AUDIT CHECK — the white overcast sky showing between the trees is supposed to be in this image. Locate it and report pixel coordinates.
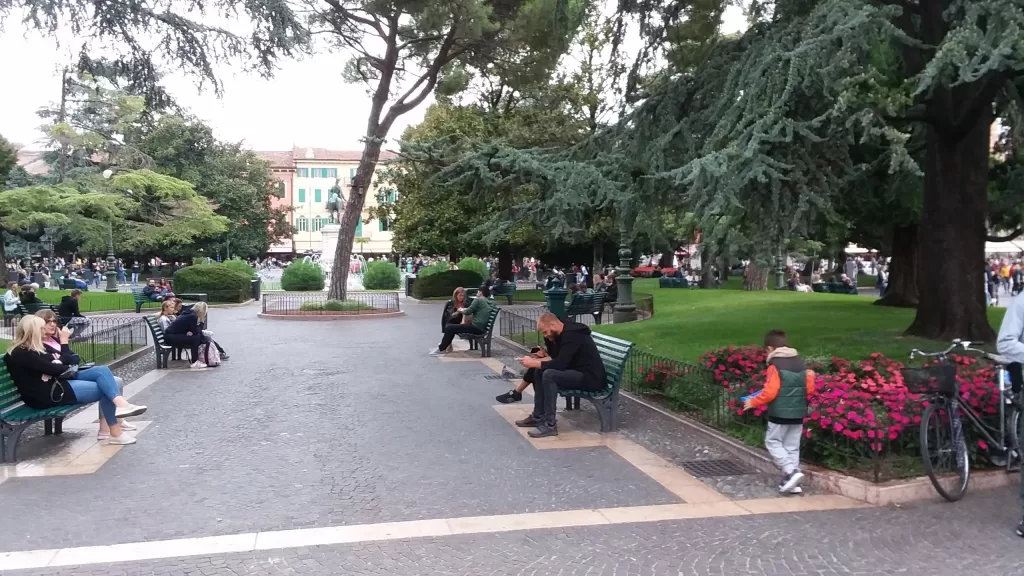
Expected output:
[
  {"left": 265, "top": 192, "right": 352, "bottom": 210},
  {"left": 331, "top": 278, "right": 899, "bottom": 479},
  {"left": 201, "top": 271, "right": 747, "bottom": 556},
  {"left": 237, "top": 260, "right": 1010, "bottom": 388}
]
[{"left": 0, "top": 7, "right": 744, "bottom": 151}]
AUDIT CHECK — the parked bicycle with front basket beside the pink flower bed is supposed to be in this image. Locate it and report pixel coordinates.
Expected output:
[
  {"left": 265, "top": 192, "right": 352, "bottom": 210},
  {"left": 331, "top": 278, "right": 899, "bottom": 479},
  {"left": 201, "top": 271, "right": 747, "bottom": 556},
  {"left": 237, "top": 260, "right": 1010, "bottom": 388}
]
[{"left": 901, "top": 338, "right": 1024, "bottom": 502}]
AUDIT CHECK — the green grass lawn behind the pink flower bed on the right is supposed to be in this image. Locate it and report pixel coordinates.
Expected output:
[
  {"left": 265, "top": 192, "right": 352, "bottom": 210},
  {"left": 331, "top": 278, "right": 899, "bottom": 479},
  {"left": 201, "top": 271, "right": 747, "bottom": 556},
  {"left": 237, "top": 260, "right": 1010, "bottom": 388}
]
[{"left": 598, "top": 279, "right": 1005, "bottom": 361}]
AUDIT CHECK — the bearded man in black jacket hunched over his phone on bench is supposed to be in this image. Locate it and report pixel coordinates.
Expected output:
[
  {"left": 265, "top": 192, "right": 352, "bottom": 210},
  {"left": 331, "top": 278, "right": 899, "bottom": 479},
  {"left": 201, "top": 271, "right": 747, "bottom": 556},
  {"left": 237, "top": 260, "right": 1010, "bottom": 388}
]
[{"left": 515, "top": 313, "right": 605, "bottom": 438}]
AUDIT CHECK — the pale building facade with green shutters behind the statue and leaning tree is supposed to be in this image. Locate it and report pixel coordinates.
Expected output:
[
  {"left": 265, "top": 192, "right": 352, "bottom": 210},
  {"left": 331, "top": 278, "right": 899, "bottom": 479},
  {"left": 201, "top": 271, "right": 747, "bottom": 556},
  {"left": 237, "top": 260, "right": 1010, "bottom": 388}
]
[{"left": 257, "top": 148, "right": 394, "bottom": 255}]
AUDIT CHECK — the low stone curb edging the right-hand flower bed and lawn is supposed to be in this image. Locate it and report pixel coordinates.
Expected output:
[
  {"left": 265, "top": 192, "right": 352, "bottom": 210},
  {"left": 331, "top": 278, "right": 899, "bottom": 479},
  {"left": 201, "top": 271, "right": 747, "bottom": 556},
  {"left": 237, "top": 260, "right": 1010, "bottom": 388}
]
[{"left": 496, "top": 335, "right": 1018, "bottom": 505}]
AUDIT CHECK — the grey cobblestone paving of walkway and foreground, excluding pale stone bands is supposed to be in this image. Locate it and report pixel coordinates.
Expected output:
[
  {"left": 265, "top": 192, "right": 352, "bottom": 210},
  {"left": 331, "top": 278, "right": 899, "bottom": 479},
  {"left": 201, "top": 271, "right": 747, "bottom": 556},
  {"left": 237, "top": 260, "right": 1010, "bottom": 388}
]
[{"left": 0, "top": 300, "right": 1024, "bottom": 576}]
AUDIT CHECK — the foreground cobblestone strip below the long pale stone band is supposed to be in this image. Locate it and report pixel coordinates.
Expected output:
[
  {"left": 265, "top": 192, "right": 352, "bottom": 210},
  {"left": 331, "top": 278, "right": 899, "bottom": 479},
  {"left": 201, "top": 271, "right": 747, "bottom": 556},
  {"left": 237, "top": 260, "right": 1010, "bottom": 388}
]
[{"left": 10, "top": 489, "right": 1024, "bottom": 576}]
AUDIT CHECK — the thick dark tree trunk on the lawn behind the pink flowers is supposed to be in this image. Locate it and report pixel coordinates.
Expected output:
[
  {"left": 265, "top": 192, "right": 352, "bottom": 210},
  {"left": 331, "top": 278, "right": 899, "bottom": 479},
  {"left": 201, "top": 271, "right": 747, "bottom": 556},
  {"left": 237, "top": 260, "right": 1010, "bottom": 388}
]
[{"left": 906, "top": 111, "right": 995, "bottom": 341}]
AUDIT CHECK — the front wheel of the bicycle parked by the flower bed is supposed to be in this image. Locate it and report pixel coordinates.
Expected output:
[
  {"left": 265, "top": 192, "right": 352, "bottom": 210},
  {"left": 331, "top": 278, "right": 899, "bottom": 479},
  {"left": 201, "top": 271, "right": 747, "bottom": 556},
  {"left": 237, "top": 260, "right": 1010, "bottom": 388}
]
[{"left": 921, "top": 401, "right": 971, "bottom": 502}]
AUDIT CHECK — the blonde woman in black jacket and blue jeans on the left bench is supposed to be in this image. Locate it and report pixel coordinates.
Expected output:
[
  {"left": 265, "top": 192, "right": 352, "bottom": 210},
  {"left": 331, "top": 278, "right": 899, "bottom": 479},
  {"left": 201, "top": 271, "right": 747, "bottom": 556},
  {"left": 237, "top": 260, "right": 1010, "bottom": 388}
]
[{"left": 3, "top": 315, "right": 145, "bottom": 445}]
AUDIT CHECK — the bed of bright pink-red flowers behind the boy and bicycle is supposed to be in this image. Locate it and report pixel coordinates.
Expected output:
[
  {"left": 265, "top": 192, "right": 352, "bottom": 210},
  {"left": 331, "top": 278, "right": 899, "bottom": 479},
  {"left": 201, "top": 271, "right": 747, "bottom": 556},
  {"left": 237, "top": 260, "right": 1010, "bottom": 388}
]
[{"left": 630, "top": 346, "right": 998, "bottom": 482}]
